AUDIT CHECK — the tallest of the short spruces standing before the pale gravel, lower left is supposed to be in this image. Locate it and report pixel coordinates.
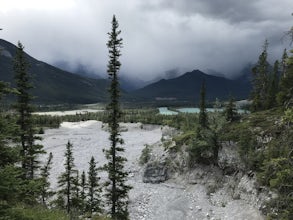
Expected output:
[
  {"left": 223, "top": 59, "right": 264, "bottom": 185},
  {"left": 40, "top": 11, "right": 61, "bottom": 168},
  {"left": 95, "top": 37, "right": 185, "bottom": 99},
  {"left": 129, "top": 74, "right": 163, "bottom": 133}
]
[{"left": 57, "top": 141, "right": 76, "bottom": 213}]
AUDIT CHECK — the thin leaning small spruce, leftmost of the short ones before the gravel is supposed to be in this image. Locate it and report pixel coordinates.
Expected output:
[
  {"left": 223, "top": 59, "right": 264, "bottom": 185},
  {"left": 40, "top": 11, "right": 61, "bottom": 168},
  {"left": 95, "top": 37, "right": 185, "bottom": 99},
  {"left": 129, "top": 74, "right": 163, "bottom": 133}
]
[{"left": 40, "top": 152, "right": 54, "bottom": 206}]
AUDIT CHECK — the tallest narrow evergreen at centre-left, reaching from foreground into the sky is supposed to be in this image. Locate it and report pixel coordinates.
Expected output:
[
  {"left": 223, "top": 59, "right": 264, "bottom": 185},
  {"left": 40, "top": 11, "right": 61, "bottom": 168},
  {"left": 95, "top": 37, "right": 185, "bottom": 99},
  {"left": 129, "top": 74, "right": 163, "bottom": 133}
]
[{"left": 104, "top": 15, "right": 131, "bottom": 220}]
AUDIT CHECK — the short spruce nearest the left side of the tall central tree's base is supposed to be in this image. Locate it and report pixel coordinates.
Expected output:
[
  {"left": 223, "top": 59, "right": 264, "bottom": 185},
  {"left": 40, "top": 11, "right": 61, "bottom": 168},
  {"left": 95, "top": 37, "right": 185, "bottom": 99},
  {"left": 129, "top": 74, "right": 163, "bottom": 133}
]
[{"left": 86, "top": 157, "right": 102, "bottom": 216}]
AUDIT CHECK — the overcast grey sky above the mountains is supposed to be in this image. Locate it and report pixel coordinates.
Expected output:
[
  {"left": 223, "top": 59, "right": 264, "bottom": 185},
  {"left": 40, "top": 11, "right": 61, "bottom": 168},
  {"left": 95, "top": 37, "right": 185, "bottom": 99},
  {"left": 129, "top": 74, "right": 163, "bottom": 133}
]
[{"left": 0, "top": 0, "right": 293, "bottom": 80}]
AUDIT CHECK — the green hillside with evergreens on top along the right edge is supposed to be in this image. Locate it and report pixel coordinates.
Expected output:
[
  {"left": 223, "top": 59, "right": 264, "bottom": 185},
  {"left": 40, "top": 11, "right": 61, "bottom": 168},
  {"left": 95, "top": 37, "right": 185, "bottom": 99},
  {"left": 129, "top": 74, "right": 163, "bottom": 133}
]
[{"left": 248, "top": 32, "right": 293, "bottom": 219}]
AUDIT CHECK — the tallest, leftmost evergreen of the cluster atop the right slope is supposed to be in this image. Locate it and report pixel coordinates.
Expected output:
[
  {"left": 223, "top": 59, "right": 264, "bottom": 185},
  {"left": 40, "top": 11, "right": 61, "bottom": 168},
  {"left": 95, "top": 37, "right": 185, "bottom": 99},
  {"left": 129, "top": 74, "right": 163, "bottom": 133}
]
[{"left": 251, "top": 40, "right": 269, "bottom": 111}]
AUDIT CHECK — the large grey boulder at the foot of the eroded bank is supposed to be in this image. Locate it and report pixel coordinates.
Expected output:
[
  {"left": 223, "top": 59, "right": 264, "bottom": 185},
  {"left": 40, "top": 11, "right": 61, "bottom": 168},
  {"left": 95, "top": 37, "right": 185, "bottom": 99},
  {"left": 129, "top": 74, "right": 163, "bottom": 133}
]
[{"left": 142, "top": 162, "right": 168, "bottom": 183}]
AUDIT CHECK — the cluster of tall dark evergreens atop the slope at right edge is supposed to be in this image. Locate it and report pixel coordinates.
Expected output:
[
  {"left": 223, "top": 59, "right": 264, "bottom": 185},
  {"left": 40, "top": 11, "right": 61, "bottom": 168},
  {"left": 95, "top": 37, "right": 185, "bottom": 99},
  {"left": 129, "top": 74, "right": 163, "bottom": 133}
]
[{"left": 251, "top": 37, "right": 293, "bottom": 112}]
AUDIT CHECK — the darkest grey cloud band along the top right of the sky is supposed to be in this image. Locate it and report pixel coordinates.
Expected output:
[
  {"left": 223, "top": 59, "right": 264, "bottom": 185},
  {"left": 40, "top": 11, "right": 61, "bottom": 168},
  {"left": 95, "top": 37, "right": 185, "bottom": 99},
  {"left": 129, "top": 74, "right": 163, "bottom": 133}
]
[{"left": 143, "top": 0, "right": 292, "bottom": 23}]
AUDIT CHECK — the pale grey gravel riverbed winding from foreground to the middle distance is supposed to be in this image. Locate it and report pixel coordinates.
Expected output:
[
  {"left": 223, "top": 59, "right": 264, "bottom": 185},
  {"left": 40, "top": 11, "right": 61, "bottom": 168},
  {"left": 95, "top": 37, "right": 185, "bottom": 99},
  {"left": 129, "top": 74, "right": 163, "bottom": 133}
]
[{"left": 41, "top": 121, "right": 264, "bottom": 220}]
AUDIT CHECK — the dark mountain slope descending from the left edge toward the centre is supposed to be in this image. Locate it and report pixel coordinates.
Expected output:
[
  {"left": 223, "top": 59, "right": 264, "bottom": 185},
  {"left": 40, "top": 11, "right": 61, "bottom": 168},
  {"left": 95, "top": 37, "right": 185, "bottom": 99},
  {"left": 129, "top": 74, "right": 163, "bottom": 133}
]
[{"left": 0, "top": 40, "right": 108, "bottom": 104}]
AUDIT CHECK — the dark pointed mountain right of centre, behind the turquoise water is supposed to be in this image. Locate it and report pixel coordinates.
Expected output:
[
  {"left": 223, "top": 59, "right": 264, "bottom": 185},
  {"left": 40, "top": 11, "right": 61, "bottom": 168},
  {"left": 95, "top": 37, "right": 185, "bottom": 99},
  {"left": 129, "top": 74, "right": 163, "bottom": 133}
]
[{"left": 133, "top": 69, "right": 250, "bottom": 102}]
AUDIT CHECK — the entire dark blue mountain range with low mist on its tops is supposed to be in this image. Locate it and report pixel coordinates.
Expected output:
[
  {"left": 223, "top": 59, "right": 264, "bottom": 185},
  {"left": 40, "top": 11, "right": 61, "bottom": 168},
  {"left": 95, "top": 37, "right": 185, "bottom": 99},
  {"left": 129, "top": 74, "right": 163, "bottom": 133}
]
[{"left": 0, "top": 40, "right": 251, "bottom": 103}]
